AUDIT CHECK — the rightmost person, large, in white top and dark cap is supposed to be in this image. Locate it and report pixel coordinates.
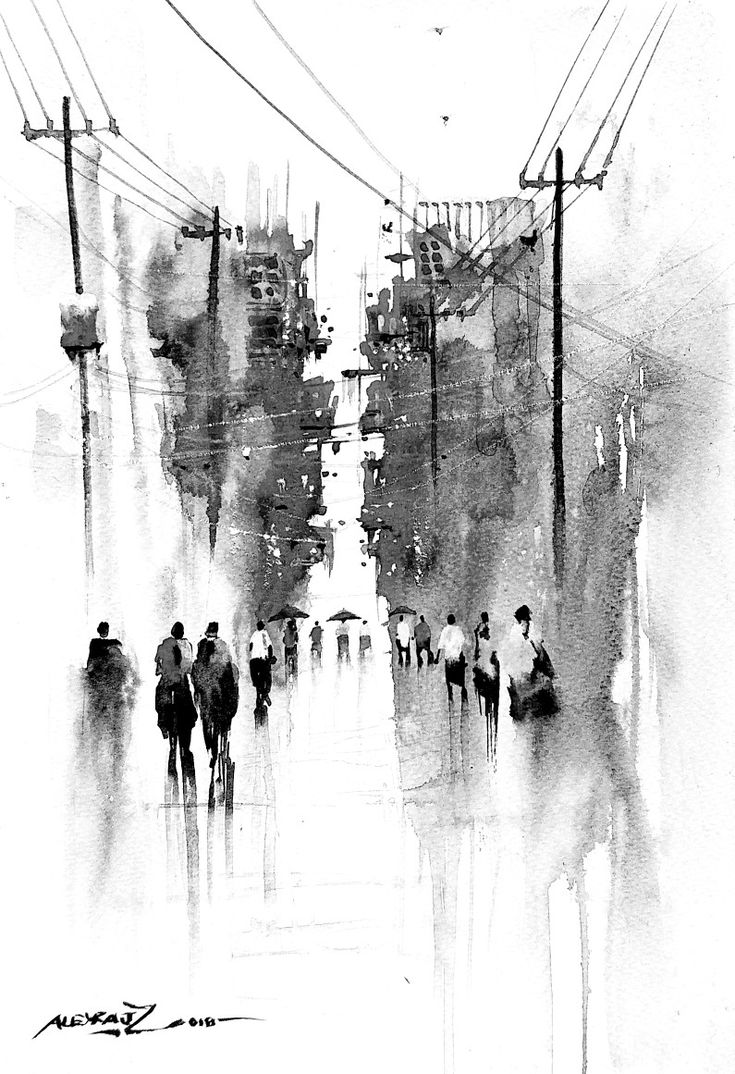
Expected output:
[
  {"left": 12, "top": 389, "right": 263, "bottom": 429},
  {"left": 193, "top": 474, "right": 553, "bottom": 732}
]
[{"left": 504, "top": 605, "right": 559, "bottom": 721}]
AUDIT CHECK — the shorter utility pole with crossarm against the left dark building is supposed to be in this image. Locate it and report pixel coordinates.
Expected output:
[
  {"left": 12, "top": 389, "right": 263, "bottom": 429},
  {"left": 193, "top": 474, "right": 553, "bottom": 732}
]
[{"left": 182, "top": 205, "right": 231, "bottom": 558}]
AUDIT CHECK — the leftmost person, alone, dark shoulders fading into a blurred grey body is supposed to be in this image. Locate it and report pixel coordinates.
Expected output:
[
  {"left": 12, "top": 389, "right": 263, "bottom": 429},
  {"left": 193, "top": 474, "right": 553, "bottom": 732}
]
[{"left": 86, "top": 621, "right": 139, "bottom": 768}]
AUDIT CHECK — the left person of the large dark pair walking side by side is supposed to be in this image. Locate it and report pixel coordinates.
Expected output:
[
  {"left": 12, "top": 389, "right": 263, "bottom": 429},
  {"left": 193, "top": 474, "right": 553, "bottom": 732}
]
[{"left": 156, "top": 623, "right": 197, "bottom": 765}]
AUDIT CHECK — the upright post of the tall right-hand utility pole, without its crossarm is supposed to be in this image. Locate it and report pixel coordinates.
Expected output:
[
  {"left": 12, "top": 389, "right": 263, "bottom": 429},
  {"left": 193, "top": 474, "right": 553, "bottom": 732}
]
[{"left": 551, "top": 147, "right": 566, "bottom": 585}]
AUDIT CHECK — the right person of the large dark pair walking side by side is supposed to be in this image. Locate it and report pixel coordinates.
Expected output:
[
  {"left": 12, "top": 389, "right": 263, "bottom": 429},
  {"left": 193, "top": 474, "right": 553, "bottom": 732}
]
[{"left": 191, "top": 622, "right": 240, "bottom": 768}]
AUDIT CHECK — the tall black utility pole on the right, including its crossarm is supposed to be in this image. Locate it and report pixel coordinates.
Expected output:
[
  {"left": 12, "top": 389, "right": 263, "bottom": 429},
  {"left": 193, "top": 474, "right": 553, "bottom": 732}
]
[{"left": 519, "top": 146, "right": 607, "bottom": 590}]
